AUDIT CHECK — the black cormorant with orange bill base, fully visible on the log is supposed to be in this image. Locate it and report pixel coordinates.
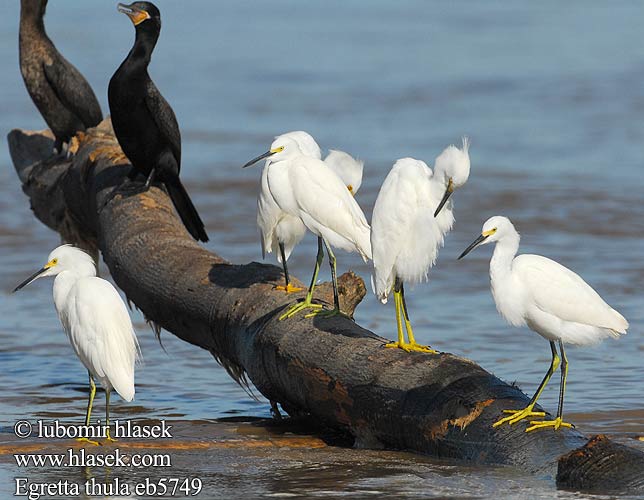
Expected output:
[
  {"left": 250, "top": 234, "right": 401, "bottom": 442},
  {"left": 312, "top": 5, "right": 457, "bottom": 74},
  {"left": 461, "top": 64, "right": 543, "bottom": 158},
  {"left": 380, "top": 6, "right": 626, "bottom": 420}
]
[{"left": 108, "top": 2, "right": 208, "bottom": 241}]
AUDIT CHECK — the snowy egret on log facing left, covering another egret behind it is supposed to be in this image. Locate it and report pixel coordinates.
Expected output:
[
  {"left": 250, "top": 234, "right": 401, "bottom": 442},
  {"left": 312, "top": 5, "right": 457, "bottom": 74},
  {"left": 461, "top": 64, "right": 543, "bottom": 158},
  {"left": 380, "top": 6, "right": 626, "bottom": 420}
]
[{"left": 244, "top": 136, "right": 371, "bottom": 319}]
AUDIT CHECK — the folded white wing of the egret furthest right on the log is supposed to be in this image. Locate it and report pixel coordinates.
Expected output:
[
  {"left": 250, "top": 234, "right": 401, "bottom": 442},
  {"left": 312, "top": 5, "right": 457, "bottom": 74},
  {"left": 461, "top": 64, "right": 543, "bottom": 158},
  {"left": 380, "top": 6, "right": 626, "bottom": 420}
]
[{"left": 512, "top": 255, "right": 628, "bottom": 332}]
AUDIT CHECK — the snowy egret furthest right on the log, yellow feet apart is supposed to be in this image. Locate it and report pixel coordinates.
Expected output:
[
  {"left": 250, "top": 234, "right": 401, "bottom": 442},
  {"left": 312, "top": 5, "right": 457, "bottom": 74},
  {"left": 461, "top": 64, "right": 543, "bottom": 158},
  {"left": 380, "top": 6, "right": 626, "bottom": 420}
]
[{"left": 459, "top": 216, "right": 628, "bottom": 432}]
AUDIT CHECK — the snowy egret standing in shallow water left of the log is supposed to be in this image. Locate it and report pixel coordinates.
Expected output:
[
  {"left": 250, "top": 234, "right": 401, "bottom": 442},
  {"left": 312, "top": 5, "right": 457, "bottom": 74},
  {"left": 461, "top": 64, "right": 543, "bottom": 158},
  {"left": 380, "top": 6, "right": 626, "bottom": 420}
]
[{"left": 14, "top": 245, "right": 139, "bottom": 444}]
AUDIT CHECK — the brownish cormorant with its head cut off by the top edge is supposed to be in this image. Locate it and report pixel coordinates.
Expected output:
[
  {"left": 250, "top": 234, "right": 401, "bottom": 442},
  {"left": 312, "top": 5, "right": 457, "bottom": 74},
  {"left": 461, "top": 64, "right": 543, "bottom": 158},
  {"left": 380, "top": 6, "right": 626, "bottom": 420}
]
[{"left": 20, "top": 0, "right": 103, "bottom": 152}]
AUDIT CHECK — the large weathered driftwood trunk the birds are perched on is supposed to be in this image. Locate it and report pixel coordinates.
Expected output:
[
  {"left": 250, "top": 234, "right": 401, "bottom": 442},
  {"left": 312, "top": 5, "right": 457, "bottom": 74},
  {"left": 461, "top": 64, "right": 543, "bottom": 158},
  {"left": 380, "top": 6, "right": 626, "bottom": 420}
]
[{"left": 8, "top": 120, "right": 644, "bottom": 490}]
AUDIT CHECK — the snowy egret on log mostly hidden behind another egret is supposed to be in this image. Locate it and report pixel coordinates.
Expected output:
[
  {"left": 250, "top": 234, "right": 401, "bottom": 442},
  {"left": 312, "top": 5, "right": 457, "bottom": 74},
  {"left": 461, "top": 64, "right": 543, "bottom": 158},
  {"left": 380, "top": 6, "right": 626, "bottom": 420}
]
[{"left": 257, "top": 130, "right": 363, "bottom": 291}]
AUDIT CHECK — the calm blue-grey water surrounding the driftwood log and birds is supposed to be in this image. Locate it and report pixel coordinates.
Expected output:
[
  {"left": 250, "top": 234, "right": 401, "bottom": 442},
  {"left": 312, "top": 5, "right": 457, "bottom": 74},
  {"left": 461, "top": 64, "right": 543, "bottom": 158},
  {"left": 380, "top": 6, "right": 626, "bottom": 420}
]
[{"left": 0, "top": 0, "right": 644, "bottom": 497}]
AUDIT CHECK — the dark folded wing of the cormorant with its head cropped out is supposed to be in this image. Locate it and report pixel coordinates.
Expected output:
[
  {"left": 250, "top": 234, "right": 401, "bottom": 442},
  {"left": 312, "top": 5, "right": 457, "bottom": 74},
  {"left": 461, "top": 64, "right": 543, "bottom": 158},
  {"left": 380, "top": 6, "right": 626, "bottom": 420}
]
[{"left": 43, "top": 56, "right": 103, "bottom": 128}]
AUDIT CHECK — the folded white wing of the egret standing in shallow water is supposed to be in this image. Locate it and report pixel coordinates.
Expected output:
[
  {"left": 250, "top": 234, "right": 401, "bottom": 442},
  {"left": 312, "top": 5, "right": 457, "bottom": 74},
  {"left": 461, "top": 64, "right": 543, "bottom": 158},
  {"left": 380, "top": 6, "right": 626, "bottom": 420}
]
[{"left": 66, "top": 277, "right": 138, "bottom": 401}]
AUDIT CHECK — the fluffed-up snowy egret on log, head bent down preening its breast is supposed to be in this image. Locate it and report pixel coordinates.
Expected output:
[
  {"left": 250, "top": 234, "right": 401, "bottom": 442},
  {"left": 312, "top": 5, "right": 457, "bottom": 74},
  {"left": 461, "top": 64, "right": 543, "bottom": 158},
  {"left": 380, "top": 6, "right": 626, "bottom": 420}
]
[{"left": 371, "top": 138, "right": 470, "bottom": 353}]
